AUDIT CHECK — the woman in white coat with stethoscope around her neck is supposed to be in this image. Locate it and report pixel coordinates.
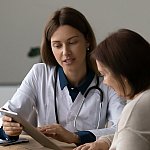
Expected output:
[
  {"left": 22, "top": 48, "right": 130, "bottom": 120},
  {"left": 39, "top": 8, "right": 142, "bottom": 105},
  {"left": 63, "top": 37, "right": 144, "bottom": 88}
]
[{"left": 0, "top": 7, "right": 125, "bottom": 144}]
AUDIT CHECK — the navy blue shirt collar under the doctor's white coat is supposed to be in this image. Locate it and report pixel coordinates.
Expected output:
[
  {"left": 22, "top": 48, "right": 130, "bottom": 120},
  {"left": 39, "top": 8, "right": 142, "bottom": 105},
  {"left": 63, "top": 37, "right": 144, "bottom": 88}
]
[{"left": 58, "top": 67, "right": 95, "bottom": 94}]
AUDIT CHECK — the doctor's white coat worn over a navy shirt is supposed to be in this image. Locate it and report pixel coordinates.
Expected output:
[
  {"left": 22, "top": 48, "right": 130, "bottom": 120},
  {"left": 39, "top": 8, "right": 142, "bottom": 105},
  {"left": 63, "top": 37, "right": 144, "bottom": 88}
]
[{"left": 3, "top": 63, "right": 125, "bottom": 138}]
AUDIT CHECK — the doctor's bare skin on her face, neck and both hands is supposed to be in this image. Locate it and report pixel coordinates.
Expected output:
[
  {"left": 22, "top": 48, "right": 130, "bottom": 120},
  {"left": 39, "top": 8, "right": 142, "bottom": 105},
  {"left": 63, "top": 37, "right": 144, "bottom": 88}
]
[{"left": 3, "top": 25, "right": 89, "bottom": 143}]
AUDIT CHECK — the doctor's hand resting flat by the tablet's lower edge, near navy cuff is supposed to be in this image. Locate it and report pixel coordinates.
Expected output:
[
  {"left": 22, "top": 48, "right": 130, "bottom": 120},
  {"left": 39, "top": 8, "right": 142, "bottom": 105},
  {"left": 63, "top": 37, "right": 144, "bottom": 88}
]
[{"left": 38, "top": 124, "right": 79, "bottom": 143}]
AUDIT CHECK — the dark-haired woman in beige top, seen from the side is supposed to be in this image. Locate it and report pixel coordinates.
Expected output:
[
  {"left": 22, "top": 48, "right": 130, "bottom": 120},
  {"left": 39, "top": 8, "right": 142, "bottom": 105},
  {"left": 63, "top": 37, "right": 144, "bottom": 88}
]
[{"left": 76, "top": 29, "right": 150, "bottom": 150}]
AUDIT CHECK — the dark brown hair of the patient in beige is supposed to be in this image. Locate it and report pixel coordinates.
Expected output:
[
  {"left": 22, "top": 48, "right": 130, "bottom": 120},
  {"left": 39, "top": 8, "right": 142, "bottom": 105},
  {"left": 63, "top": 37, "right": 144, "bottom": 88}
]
[{"left": 92, "top": 29, "right": 150, "bottom": 98}]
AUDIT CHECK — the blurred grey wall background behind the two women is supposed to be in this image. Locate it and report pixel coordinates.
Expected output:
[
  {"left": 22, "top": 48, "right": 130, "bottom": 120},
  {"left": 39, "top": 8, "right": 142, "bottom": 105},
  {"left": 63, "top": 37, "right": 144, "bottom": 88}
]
[{"left": 0, "top": 0, "right": 150, "bottom": 106}]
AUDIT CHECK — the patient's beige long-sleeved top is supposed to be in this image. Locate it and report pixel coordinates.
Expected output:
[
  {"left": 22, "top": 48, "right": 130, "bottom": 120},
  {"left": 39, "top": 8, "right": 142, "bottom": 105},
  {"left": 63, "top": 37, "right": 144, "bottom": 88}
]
[{"left": 99, "top": 90, "right": 150, "bottom": 150}]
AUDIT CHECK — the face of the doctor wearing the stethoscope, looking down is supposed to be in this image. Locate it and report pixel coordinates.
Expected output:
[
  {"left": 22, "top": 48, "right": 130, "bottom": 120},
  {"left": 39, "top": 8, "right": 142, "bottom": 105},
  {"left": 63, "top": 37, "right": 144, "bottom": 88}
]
[{"left": 51, "top": 25, "right": 89, "bottom": 72}]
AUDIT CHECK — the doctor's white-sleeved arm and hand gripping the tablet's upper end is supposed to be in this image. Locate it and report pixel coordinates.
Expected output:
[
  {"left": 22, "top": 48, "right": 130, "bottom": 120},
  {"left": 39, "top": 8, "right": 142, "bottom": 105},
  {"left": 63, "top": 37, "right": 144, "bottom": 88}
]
[{"left": 0, "top": 63, "right": 40, "bottom": 137}]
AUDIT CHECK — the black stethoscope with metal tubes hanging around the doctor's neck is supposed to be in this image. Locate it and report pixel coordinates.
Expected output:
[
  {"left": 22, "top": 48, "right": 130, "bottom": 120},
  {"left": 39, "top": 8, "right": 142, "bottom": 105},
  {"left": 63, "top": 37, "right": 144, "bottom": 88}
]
[{"left": 54, "top": 66, "right": 103, "bottom": 131}]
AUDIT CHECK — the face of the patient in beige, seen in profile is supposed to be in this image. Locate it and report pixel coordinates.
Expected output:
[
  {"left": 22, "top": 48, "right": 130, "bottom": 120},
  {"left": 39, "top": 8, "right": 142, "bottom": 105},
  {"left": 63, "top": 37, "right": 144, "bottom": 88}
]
[{"left": 96, "top": 60, "right": 131, "bottom": 98}]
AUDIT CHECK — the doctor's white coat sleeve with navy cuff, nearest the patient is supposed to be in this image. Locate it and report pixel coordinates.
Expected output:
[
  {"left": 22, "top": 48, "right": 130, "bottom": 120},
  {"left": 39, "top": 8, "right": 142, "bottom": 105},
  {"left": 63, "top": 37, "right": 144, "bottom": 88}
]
[{"left": 54, "top": 85, "right": 126, "bottom": 145}]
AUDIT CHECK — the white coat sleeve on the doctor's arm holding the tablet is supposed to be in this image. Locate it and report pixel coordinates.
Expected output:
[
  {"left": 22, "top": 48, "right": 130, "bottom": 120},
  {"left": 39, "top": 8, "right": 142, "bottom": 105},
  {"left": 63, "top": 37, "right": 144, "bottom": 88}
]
[{"left": 3, "top": 65, "right": 38, "bottom": 123}]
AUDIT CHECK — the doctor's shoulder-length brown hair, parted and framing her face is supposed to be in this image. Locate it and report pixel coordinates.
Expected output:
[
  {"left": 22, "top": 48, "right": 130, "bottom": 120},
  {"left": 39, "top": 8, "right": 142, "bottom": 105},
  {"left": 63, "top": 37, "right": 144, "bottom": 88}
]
[{"left": 41, "top": 7, "right": 96, "bottom": 70}]
